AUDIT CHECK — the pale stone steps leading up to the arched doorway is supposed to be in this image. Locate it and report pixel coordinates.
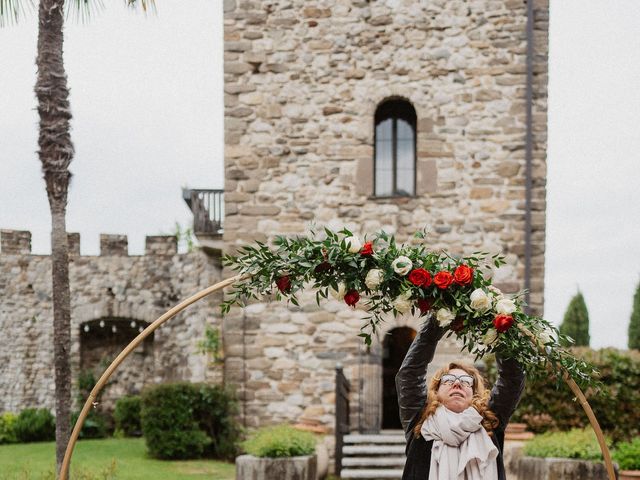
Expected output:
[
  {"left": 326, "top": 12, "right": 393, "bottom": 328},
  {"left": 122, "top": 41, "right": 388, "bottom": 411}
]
[{"left": 340, "top": 430, "right": 405, "bottom": 480}]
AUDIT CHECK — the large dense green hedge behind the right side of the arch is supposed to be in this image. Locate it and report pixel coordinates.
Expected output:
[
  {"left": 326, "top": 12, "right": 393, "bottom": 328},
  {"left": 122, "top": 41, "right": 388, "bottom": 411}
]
[{"left": 502, "top": 348, "right": 640, "bottom": 442}]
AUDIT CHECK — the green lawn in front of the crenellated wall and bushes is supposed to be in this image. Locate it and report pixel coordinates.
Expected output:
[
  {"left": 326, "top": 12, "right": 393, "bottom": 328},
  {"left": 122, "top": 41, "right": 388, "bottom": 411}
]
[{"left": 0, "top": 438, "right": 235, "bottom": 480}]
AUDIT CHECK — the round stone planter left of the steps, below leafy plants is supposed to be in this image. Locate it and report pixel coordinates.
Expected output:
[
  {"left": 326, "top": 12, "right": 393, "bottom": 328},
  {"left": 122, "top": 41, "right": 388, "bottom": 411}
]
[{"left": 236, "top": 455, "right": 317, "bottom": 480}]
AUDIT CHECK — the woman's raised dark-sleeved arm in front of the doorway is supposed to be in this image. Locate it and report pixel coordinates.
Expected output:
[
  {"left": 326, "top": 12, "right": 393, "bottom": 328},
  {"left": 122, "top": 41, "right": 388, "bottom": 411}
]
[{"left": 396, "top": 318, "right": 444, "bottom": 434}]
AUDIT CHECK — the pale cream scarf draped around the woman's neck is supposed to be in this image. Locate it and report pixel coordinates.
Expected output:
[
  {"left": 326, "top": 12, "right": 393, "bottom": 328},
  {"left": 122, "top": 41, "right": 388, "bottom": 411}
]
[{"left": 420, "top": 405, "right": 498, "bottom": 480}]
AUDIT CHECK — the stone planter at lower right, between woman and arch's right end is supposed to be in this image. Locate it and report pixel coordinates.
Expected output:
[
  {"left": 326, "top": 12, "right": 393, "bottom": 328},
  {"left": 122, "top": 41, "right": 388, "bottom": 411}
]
[{"left": 518, "top": 457, "right": 609, "bottom": 480}]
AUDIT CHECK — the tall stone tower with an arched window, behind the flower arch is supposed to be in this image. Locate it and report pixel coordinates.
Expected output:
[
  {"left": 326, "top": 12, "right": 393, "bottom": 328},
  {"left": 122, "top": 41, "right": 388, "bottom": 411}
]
[{"left": 223, "top": 0, "right": 548, "bottom": 438}]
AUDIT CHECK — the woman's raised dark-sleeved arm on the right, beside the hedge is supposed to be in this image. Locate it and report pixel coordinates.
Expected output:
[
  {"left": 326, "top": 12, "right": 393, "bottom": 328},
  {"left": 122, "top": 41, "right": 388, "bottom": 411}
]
[{"left": 489, "top": 355, "right": 525, "bottom": 429}]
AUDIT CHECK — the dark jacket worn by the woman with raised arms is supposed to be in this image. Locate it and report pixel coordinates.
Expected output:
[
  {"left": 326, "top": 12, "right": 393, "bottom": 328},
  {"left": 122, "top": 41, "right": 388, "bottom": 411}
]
[{"left": 396, "top": 319, "right": 524, "bottom": 480}]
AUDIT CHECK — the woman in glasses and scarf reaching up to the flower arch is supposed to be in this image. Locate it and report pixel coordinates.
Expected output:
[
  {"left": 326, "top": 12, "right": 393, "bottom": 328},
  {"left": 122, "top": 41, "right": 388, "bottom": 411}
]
[{"left": 396, "top": 319, "right": 524, "bottom": 480}]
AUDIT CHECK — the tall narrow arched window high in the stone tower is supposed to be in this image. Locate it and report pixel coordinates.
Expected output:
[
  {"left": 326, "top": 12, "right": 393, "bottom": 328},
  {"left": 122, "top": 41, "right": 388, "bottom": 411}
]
[{"left": 374, "top": 98, "right": 416, "bottom": 197}]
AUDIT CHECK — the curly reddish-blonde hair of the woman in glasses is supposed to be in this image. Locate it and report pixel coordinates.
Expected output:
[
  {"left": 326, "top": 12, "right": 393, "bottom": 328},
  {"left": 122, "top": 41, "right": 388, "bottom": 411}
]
[{"left": 413, "top": 362, "right": 500, "bottom": 438}]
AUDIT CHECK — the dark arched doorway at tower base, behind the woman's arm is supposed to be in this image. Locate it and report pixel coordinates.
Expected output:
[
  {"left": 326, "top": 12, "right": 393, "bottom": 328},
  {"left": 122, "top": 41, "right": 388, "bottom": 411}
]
[{"left": 382, "top": 327, "right": 416, "bottom": 430}]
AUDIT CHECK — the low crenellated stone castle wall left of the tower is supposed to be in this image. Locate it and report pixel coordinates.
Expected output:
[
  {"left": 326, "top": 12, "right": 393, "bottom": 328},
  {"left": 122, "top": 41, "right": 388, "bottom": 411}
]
[{"left": 0, "top": 230, "right": 222, "bottom": 412}]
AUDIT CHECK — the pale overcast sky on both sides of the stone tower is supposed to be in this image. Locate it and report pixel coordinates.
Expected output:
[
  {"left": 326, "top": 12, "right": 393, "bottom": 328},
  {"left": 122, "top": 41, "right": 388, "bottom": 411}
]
[{"left": 0, "top": 0, "right": 640, "bottom": 348}]
